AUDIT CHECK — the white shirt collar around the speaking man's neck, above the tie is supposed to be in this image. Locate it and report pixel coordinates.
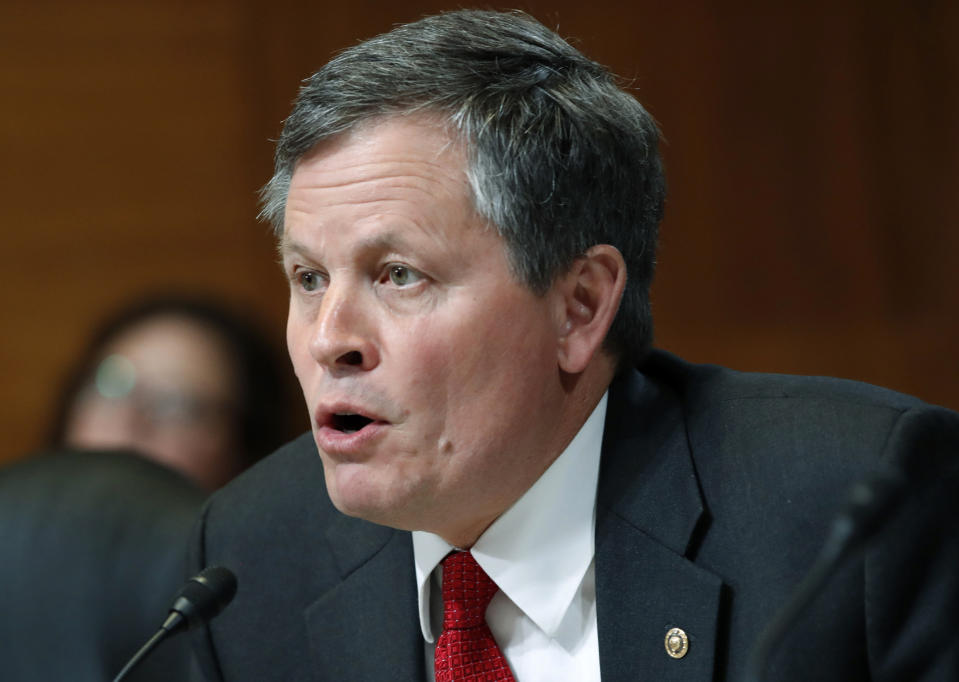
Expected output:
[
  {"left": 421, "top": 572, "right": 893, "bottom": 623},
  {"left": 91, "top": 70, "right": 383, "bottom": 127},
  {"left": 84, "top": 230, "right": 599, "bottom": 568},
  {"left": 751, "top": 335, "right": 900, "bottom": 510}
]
[{"left": 413, "top": 394, "right": 607, "bottom": 642}]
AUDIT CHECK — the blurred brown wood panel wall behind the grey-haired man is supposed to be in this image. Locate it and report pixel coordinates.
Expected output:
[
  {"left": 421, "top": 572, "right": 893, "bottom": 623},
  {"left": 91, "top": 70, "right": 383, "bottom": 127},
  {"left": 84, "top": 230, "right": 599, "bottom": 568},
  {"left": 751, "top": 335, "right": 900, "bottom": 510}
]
[{"left": 0, "top": 0, "right": 959, "bottom": 459}]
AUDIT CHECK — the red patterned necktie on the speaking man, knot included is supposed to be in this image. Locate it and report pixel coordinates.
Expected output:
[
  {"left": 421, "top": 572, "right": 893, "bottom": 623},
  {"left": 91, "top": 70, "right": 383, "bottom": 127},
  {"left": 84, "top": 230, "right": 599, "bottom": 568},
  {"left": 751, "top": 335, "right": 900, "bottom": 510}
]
[{"left": 436, "top": 552, "right": 513, "bottom": 682}]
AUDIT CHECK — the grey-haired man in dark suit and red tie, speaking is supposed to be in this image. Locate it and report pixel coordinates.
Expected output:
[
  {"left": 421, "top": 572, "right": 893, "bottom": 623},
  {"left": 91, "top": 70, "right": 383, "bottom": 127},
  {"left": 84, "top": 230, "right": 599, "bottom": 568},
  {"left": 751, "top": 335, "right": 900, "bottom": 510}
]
[{"left": 184, "top": 12, "right": 959, "bottom": 682}]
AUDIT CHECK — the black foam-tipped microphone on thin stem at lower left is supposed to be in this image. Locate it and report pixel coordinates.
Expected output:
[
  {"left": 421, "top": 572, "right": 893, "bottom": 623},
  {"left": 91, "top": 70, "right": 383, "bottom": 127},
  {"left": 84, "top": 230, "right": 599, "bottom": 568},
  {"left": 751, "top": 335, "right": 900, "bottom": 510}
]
[{"left": 113, "top": 566, "right": 236, "bottom": 682}]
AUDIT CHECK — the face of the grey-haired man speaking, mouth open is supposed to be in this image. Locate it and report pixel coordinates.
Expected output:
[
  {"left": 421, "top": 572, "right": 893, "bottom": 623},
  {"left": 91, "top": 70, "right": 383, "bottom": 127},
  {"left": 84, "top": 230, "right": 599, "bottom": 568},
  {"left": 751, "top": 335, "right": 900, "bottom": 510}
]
[{"left": 281, "top": 118, "right": 569, "bottom": 543}]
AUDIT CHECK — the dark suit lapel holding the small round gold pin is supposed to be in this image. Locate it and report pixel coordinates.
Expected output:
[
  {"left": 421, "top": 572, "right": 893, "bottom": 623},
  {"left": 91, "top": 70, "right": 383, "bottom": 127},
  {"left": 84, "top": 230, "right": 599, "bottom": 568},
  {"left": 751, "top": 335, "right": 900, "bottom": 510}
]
[{"left": 596, "top": 373, "right": 722, "bottom": 682}]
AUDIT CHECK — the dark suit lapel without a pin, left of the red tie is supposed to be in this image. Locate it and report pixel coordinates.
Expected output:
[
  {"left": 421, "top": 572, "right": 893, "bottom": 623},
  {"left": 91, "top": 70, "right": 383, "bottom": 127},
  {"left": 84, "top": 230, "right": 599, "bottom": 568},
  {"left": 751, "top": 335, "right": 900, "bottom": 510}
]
[{"left": 304, "top": 516, "right": 426, "bottom": 681}]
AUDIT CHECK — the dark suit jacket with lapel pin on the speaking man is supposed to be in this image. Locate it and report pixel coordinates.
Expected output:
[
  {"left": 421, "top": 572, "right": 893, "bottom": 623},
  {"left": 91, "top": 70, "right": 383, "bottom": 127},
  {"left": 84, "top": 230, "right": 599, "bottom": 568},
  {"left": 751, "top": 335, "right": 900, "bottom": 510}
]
[{"left": 192, "top": 352, "right": 959, "bottom": 682}]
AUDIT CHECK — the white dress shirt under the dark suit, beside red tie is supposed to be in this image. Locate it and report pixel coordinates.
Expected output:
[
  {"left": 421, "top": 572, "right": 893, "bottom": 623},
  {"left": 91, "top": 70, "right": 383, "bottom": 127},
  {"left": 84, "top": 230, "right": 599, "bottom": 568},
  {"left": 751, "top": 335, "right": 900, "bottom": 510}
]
[{"left": 413, "top": 395, "right": 607, "bottom": 682}]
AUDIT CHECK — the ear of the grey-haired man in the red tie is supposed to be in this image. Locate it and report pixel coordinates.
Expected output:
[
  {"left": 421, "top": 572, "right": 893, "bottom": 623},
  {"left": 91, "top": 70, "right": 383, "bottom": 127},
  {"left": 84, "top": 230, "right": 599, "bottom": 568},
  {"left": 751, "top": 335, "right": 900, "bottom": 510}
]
[{"left": 557, "top": 244, "right": 626, "bottom": 374}]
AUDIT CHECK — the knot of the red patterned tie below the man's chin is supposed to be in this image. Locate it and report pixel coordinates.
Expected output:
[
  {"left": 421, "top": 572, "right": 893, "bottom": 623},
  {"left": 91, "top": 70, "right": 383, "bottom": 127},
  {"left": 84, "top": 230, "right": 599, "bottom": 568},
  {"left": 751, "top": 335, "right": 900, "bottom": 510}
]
[{"left": 443, "top": 552, "right": 499, "bottom": 630}]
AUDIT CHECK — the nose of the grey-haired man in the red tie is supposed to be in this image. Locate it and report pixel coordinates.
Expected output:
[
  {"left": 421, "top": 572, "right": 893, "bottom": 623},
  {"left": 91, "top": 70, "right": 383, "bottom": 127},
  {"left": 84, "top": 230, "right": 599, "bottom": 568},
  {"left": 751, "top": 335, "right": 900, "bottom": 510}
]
[{"left": 310, "top": 283, "right": 379, "bottom": 374}]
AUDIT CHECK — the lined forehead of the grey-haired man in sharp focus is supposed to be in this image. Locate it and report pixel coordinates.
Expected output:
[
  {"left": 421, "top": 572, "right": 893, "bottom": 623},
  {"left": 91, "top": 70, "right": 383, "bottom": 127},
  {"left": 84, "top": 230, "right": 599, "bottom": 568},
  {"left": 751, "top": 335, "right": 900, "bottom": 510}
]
[{"left": 280, "top": 115, "right": 495, "bottom": 254}]
